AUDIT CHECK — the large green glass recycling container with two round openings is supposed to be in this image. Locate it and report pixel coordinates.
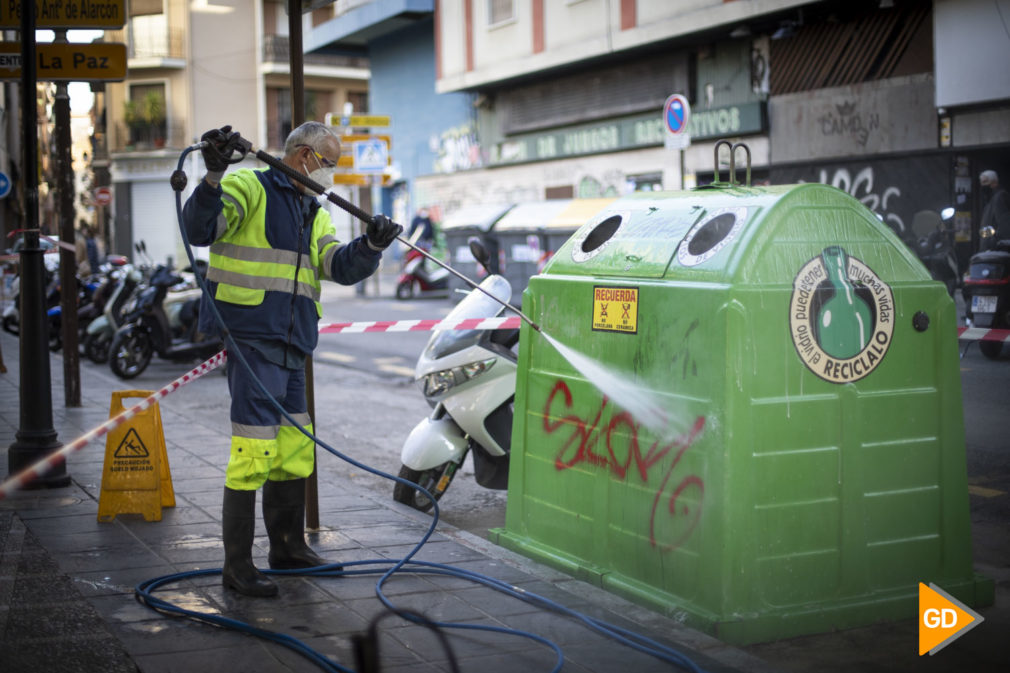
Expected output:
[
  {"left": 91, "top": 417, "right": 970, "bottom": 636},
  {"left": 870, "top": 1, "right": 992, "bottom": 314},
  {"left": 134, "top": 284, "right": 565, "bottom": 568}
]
[{"left": 492, "top": 184, "right": 993, "bottom": 644}]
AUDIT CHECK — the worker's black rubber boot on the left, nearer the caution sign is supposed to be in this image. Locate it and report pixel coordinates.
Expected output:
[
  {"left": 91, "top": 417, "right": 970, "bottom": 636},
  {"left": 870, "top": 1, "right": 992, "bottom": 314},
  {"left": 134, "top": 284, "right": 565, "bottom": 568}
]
[{"left": 221, "top": 487, "right": 277, "bottom": 596}]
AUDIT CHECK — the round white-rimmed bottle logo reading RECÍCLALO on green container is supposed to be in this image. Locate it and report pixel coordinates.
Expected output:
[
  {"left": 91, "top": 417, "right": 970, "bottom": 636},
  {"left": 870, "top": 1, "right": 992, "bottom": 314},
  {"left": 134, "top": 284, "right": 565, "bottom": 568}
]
[{"left": 789, "top": 246, "right": 894, "bottom": 383}]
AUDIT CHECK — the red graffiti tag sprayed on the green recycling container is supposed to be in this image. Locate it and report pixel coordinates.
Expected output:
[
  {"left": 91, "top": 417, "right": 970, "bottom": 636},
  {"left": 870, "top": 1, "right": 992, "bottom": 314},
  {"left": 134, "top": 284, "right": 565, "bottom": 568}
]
[{"left": 543, "top": 381, "right": 705, "bottom": 552}]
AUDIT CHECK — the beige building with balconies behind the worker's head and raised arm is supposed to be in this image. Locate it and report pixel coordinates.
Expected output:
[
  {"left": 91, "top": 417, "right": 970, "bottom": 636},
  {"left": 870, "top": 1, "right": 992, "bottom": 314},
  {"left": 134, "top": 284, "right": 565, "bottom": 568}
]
[{"left": 94, "top": 0, "right": 369, "bottom": 262}]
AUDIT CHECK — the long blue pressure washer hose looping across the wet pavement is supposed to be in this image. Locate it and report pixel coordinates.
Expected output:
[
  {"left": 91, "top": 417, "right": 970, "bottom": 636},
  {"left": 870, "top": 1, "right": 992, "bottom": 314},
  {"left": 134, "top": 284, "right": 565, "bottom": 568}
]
[{"left": 134, "top": 146, "right": 704, "bottom": 673}]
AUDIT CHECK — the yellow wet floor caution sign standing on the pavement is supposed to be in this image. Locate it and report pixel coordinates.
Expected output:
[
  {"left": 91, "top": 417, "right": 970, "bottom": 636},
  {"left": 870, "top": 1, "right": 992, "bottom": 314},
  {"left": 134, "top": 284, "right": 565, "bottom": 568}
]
[{"left": 98, "top": 390, "right": 176, "bottom": 521}]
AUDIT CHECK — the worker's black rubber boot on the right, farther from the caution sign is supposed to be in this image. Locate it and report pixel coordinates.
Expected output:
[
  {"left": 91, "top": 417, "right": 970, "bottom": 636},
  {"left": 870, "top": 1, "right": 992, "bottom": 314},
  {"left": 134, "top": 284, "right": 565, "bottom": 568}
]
[{"left": 263, "top": 479, "right": 339, "bottom": 570}]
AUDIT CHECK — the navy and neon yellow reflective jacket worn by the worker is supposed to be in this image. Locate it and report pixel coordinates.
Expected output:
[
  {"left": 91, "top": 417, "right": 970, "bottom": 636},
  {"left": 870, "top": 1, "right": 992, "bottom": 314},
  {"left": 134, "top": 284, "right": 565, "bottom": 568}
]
[{"left": 184, "top": 163, "right": 380, "bottom": 355}]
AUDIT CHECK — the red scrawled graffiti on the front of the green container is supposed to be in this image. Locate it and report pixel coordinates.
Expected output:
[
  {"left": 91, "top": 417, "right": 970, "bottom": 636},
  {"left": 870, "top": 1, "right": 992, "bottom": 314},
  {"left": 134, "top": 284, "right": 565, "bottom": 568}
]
[{"left": 543, "top": 379, "right": 705, "bottom": 553}]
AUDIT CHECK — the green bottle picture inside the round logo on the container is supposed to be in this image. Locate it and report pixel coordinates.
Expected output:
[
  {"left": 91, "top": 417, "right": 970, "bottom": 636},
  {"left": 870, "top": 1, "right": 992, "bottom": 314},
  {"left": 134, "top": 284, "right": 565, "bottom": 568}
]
[{"left": 814, "top": 246, "right": 873, "bottom": 360}]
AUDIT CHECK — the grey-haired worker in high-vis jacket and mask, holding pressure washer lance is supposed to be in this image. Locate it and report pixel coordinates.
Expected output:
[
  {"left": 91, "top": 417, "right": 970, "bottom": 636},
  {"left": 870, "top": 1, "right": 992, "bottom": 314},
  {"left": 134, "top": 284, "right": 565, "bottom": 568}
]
[{"left": 183, "top": 121, "right": 403, "bottom": 596}]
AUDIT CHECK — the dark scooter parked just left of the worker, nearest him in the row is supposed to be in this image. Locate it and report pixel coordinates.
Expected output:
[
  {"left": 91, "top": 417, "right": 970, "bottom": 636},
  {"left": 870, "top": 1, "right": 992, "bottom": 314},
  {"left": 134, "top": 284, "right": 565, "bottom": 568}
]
[{"left": 109, "top": 265, "right": 223, "bottom": 379}]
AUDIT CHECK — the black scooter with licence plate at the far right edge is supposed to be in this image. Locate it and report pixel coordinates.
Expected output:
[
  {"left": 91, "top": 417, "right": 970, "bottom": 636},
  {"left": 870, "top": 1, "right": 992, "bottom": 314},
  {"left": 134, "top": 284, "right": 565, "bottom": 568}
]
[{"left": 963, "top": 226, "right": 1010, "bottom": 360}]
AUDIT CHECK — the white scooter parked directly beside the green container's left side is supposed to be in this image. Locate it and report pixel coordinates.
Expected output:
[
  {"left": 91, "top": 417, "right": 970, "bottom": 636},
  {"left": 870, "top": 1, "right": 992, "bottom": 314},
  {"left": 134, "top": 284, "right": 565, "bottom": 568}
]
[{"left": 393, "top": 237, "right": 519, "bottom": 511}]
